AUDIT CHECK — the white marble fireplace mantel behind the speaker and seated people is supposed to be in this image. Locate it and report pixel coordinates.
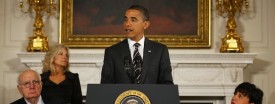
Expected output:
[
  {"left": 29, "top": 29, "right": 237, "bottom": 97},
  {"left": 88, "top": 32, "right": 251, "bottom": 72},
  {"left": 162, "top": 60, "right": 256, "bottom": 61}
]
[{"left": 17, "top": 52, "right": 257, "bottom": 104}]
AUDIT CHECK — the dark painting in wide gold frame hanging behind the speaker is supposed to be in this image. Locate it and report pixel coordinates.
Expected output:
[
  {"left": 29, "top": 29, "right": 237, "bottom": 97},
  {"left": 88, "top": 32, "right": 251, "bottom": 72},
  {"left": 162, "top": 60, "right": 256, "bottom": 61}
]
[{"left": 59, "top": 0, "right": 211, "bottom": 48}]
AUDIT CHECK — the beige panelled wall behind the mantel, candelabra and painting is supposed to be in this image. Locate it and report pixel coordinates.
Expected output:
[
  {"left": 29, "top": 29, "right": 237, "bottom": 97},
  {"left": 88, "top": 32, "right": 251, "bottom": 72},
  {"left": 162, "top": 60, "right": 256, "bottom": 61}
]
[{"left": 0, "top": 0, "right": 275, "bottom": 104}]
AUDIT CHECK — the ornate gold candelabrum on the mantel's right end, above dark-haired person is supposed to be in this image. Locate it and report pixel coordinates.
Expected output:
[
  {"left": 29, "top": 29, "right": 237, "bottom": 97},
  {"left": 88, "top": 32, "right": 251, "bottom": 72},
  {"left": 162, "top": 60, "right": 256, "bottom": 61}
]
[{"left": 216, "top": 0, "right": 249, "bottom": 53}]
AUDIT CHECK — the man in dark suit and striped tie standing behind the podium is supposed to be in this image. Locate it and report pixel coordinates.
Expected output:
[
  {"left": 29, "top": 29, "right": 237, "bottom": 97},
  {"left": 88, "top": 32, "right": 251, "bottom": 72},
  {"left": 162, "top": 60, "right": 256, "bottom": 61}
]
[{"left": 101, "top": 5, "right": 173, "bottom": 84}]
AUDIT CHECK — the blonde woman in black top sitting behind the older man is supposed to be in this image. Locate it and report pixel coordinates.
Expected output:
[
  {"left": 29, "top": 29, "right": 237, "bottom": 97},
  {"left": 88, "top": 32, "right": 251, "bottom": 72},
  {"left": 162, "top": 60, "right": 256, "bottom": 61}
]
[{"left": 41, "top": 45, "right": 82, "bottom": 104}]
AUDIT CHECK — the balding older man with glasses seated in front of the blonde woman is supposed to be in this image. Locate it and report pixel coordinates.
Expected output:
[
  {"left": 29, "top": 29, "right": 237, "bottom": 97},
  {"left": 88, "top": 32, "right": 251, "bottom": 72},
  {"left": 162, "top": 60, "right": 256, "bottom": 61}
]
[{"left": 11, "top": 69, "right": 65, "bottom": 104}]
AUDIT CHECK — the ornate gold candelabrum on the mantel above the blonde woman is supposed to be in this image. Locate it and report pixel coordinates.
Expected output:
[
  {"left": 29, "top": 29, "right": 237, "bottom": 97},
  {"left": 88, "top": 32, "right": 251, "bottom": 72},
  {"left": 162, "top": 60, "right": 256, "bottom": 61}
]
[{"left": 19, "top": 0, "right": 57, "bottom": 52}]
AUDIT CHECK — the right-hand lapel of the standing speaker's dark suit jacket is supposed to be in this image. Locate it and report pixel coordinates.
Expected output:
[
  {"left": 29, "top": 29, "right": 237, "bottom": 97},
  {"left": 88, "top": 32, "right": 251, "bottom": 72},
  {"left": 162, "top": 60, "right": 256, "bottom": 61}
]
[{"left": 141, "top": 38, "right": 152, "bottom": 83}]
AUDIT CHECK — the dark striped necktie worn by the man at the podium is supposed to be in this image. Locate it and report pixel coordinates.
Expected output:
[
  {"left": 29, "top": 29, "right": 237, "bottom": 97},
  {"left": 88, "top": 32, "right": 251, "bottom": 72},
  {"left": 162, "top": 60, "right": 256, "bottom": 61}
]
[{"left": 133, "top": 43, "right": 142, "bottom": 84}]
